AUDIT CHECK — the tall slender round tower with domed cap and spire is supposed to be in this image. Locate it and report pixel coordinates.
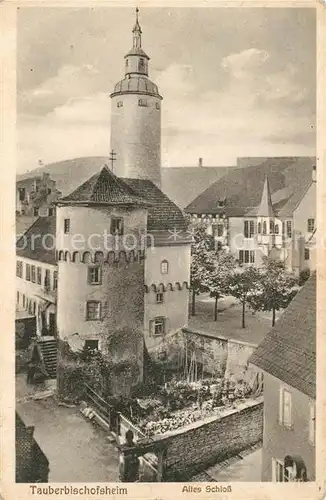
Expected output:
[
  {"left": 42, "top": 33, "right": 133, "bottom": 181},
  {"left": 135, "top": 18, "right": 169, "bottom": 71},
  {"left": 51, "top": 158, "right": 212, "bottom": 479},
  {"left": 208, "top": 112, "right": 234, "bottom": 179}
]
[{"left": 111, "top": 8, "right": 162, "bottom": 187}]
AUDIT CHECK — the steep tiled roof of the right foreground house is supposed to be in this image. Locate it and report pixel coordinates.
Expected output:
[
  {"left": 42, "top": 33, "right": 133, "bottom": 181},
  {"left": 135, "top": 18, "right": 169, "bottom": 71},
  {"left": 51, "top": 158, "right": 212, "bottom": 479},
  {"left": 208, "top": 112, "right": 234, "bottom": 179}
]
[{"left": 249, "top": 273, "right": 316, "bottom": 398}]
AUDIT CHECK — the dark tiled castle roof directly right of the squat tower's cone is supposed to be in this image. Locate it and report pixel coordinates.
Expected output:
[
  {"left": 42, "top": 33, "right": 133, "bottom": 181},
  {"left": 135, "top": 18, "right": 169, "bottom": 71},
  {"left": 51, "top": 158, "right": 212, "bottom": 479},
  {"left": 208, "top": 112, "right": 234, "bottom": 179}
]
[{"left": 124, "top": 179, "right": 187, "bottom": 231}]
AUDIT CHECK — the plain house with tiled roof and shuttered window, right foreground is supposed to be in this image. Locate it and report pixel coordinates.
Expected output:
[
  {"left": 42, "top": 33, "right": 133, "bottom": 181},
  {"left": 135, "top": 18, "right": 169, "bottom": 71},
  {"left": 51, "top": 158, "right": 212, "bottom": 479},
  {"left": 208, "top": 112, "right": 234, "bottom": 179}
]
[{"left": 249, "top": 273, "right": 316, "bottom": 482}]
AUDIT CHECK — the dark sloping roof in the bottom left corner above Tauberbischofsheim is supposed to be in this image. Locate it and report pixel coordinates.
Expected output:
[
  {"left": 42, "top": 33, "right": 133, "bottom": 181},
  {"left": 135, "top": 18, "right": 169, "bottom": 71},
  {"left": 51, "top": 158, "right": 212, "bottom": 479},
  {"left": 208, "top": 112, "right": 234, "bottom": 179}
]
[{"left": 16, "top": 412, "right": 49, "bottom": 483}]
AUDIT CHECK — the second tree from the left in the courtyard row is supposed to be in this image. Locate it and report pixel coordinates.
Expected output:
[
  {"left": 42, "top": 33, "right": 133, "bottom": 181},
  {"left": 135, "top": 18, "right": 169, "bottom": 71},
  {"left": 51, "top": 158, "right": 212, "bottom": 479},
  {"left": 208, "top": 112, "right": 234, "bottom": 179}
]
[{"left": 206, "top": 249, "right": 235, "bottom": 321}]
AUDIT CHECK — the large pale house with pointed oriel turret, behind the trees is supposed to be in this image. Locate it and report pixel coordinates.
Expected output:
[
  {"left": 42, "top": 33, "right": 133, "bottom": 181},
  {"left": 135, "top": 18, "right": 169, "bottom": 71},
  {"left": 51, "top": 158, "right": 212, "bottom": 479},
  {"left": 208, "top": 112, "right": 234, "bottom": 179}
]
[{"left": 185, "top": 158, "right": 316, "bottom": 274}]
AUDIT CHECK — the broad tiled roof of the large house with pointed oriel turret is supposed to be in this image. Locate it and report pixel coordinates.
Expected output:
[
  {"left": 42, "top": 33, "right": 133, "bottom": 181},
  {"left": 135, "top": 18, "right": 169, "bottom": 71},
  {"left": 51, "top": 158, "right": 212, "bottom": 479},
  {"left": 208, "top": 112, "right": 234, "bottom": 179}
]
[{"left": 185, "top": 157, "right": 316, "bottom": 217}]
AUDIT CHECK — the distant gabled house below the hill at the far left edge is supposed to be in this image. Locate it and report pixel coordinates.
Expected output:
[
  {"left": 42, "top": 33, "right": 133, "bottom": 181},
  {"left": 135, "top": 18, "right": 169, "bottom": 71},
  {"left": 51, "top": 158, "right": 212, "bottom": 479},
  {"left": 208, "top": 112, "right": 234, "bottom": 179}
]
[{"left": 16, "top": 172, "right": 61, "bottom": 217}]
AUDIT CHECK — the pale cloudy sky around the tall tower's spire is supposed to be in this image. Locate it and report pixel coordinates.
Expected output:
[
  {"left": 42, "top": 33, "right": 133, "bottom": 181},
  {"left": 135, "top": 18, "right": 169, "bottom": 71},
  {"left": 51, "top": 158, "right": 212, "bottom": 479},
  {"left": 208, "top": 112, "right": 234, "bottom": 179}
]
[{"left": 17, "top": 7, "right": 316, "bottom": 173}]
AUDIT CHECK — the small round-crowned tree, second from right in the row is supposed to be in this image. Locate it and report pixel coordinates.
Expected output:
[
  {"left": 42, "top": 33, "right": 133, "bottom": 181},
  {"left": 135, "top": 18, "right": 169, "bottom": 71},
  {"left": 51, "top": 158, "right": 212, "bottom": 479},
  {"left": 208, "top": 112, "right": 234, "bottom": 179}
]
[{"left": 226, "top": 267, "right": 259, "bottom": 328}]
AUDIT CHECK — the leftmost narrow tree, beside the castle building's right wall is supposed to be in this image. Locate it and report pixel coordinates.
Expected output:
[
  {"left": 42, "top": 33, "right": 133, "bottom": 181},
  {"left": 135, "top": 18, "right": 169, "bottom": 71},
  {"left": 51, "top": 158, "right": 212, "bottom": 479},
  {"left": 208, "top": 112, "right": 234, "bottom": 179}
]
[{"left": 190, "top": 222, "right": 214, "bottom": 316}]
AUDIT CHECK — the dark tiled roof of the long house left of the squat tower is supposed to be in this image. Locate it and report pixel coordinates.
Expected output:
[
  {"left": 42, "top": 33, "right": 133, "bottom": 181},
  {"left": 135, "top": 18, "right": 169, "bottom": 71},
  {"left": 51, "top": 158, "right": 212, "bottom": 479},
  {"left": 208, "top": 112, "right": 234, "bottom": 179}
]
[{"left": 16, "top": 215, "right": 56, "bottom": 264}]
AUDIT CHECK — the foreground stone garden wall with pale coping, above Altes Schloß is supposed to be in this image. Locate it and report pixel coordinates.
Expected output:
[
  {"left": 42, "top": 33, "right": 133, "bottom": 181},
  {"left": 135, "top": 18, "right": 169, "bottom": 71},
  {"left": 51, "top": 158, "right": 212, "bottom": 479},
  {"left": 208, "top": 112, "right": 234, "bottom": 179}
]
[{"left": 159, "top": 398, "right": 263, "bottom": 481}]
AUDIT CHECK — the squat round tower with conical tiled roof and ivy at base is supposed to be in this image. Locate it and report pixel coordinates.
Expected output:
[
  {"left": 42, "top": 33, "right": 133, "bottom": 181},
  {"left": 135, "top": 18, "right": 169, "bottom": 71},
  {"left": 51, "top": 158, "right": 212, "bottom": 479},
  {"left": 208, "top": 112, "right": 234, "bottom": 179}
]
[{"left": 56, "top": 167, "right": 148, "bottom": 394}]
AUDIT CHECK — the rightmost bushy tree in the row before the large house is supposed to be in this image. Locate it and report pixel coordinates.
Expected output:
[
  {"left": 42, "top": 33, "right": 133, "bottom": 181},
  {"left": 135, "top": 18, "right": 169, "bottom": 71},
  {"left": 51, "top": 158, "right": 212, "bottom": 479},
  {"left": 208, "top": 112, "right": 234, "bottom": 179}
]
[{"left": 249, "top": 257, "right": 298, "bottom": 326}]
